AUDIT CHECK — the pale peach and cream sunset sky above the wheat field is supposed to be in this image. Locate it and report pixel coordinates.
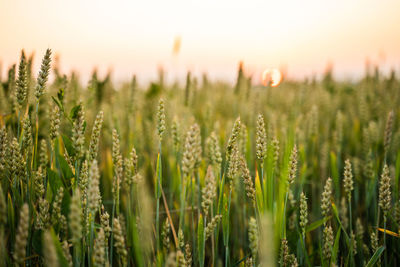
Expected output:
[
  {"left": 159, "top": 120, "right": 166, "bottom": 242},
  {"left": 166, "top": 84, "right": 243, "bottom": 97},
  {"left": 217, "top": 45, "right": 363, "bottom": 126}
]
[{"left": 0, "top": 0, "right": 400, "bottom": 84}]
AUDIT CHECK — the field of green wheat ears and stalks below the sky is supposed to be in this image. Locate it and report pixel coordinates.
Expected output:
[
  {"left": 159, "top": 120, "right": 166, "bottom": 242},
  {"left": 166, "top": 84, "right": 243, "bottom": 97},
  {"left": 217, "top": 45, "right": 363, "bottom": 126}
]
[{"left": 0, "top": 50, "right": 400, "bottom": 266}]
